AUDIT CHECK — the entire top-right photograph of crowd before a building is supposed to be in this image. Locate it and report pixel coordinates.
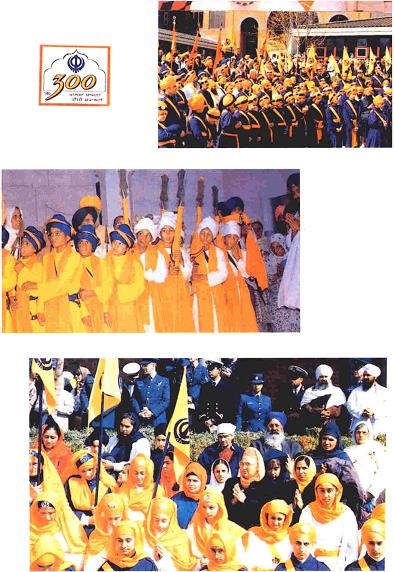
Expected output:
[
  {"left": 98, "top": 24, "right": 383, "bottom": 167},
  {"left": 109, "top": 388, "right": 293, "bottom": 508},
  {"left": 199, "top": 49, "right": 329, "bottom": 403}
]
[{"left": 158, "top": 0, "right": 392, "bottom": 148}]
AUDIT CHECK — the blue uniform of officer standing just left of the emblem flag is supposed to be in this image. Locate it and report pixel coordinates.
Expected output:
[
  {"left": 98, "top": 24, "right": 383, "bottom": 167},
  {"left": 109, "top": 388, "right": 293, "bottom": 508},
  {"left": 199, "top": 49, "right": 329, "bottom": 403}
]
[{"left": 132, "top": 374, "right": 170, "bottom": 427}]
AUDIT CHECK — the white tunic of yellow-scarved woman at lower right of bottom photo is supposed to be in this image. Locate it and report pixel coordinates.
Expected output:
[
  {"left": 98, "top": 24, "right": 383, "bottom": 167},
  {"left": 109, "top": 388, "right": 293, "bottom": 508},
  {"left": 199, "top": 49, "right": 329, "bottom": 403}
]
[{"left": 300, "top": 506, "right": 359, "bottom": 572}]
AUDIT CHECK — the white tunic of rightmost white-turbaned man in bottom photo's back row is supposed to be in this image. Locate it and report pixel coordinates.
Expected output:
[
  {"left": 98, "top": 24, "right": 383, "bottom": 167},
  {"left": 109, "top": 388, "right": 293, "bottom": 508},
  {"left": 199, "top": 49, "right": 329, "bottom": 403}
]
[{"left": 346, "top": 383, "right": 387, "bottom": 436}]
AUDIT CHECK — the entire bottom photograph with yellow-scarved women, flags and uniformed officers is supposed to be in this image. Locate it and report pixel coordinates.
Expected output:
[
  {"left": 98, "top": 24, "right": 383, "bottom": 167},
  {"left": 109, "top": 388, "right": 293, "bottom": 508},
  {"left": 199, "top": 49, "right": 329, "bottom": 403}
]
[{"left": 29, "top": 357, "right": 388, "bottom": 572}]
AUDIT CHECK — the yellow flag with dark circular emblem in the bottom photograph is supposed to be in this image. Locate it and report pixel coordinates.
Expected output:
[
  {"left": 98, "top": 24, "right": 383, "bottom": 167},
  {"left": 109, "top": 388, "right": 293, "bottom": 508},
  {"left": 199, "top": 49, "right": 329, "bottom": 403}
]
[{"left": 167, "top": 367, "right": 190, "bottom": 481}]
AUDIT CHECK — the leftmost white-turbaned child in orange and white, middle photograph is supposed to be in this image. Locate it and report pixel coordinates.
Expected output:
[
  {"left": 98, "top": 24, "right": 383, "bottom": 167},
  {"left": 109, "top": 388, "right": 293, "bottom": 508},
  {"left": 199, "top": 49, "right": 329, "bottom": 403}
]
[{"left": 134, "top": 218, "right": 170, "bottom": 332}]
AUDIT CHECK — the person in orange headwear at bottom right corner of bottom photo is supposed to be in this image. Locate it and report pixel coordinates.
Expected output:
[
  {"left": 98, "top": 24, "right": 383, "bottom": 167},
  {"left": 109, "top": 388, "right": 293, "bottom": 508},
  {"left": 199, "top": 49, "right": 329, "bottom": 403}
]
[{"left": 345, "top": 518, "right": 386, "bottom": 571}]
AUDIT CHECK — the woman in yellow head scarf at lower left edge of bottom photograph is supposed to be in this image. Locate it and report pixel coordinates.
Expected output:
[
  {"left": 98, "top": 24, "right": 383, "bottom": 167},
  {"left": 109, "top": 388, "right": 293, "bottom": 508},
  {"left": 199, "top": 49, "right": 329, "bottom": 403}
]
[{"left": 30, "top": 491, "right": 87, "bottom": 569}]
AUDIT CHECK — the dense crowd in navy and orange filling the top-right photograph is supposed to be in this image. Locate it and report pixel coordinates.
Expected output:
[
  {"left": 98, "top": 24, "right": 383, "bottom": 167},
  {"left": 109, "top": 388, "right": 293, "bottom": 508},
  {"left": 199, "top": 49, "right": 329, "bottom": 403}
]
[{"left": 158, "top": 50, "right": 392, "bottom": 148}]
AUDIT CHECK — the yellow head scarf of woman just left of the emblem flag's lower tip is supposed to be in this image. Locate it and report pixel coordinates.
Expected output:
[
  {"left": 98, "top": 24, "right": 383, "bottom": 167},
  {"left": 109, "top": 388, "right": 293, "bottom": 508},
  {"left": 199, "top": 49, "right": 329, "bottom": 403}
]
[{"left": 119, "top": 454, "right": 157, "bottom": 514}]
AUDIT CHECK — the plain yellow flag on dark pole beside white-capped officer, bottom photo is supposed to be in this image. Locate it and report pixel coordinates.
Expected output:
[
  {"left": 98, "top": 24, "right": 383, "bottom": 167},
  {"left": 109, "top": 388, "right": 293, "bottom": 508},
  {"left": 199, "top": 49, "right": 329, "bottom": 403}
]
[{"left": 88, "top": 358, "right": 120, "bottom": 426}]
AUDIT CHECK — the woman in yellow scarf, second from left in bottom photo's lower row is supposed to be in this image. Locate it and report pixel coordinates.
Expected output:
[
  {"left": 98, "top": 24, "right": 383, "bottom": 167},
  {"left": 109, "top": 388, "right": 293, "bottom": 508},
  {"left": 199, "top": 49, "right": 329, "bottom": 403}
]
[{"left": 84, "top": 493, "right": 127, "bottom": 572}]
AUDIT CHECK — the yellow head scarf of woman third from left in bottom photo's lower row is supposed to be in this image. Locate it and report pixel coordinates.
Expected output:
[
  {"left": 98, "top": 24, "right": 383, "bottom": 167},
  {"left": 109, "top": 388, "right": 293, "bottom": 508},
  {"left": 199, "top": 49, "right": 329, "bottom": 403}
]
[{"left": 144, "top": 497, "right": 197, "bottom": 570}]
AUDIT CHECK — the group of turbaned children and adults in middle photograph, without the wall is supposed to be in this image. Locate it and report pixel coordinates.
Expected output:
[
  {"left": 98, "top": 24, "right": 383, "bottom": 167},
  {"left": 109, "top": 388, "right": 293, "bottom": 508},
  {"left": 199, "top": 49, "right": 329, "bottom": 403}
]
[{"left": 2, "top": 174, "right": 300, "bottom": 333}]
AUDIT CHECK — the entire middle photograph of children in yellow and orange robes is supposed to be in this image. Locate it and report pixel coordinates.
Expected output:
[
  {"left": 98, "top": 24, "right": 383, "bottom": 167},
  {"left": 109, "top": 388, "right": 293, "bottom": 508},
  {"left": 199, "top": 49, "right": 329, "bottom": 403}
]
[{"left": 2, "top": 169, "right": 300, "bottom": 333}]
